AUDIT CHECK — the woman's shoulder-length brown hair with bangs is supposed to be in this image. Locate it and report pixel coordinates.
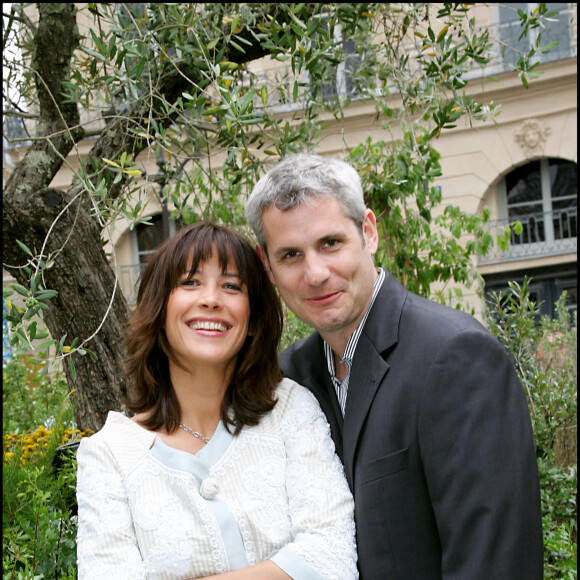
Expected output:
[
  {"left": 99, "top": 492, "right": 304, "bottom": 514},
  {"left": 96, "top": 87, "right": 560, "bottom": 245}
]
[{"left": 125, "top": 222, "right": 283, "bottom": 435}]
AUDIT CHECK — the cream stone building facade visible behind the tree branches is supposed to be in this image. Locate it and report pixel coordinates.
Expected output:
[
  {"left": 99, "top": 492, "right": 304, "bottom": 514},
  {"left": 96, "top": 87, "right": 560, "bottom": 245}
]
[{"left": 4, "top": 3, "right": 577, "bottom": 318}]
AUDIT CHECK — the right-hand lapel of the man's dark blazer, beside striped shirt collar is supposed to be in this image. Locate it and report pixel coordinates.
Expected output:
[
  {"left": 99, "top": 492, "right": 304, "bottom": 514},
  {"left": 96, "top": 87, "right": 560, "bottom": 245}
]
[{"left": 343, "top": 272, "right": 407, "bottom": 488}]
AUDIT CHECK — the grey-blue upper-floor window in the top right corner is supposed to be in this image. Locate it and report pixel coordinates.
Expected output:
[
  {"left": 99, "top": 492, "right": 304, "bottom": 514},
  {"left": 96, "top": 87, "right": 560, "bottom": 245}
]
[{"left": 496, "top": 2, "right": 576, "bottom": 69}]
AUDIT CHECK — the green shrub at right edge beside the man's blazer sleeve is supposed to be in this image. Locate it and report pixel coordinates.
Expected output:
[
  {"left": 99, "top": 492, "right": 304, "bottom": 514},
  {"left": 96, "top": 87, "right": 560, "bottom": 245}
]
[{"left": 489, "top": 279, "right": 578, "bottom": 578}]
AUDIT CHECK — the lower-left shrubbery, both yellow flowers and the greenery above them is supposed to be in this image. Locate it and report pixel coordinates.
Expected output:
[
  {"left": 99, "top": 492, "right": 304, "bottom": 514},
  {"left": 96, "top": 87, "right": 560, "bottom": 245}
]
[{"left": 2, "top": 357, "right": 91, "bottom": 580}]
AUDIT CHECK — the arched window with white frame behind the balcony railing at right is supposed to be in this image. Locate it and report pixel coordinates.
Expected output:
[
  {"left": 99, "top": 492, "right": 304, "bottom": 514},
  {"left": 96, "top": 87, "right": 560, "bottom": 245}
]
[{"left": 500, "top": 159, "right": 577, "bottom": 246}]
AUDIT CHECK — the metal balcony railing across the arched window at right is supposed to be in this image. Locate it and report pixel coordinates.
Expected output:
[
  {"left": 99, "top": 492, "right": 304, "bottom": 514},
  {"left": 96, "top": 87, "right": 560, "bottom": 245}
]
[{"left": 479, "top": 207, "right": 578, "bottom": 265}]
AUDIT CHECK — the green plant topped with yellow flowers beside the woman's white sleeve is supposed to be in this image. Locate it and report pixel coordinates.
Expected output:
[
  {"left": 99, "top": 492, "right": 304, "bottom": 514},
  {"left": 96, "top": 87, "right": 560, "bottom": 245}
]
[{"left": 2, "top": 380, "right": 91, "bottom": 579}]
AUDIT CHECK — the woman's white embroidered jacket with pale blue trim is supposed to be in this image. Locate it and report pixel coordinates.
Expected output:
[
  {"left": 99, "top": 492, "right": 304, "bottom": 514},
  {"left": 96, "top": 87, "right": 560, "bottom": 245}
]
[{"left": 77, "top": 379, "right": 358, "bottom": 580}]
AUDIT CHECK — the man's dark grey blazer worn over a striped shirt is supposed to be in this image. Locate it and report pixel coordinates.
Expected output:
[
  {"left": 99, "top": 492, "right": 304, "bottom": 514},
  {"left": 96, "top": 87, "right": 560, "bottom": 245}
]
[{"left": 280, "top": 273, "right": 543, "bottom": 580}]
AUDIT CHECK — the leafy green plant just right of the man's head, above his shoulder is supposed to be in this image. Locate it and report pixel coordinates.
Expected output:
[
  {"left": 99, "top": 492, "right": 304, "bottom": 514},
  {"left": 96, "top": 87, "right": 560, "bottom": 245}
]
[{"left": 348, "top": 138, "right": 493, "bottom": 304}]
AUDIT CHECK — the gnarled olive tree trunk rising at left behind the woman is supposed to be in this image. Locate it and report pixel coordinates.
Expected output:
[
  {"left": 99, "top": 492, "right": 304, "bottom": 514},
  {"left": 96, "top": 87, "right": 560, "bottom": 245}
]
[{"left": 2, "top": 3, "right": 128, "bottom": 430}]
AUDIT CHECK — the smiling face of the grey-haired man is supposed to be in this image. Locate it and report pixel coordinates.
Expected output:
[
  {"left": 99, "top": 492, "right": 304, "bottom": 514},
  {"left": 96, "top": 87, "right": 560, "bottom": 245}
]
[{"left": 261, "top": 197, "right": 378, "bottom": 348}]
